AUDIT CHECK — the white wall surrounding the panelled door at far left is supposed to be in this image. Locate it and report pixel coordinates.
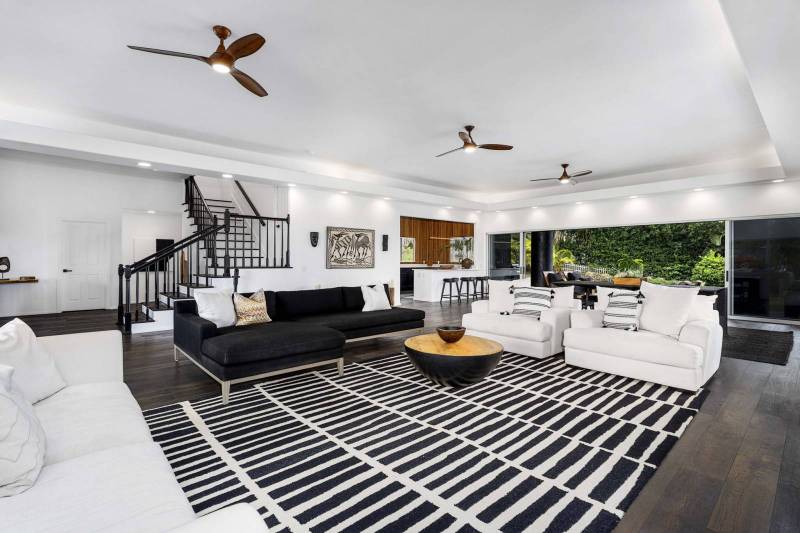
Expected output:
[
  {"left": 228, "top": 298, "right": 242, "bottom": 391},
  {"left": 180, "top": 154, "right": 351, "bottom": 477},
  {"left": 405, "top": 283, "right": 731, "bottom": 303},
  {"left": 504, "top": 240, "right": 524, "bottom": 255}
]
[{"left": 0, "top": 150, "right": 183, "bottom": 316}]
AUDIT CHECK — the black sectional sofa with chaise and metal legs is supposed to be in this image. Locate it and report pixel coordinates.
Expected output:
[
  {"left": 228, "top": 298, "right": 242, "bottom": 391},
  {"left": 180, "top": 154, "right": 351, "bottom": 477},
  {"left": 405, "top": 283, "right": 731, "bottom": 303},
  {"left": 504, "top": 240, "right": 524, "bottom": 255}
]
[{"left": 174, "top": 286, "right": 425, "bottom": 403}]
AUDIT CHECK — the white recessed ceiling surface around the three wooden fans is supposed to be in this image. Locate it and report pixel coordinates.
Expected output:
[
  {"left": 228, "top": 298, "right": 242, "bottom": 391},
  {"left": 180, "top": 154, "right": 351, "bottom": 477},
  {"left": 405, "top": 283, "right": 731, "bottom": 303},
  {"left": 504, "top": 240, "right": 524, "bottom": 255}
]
[{"left": 0, "top": 0, "right": 788, "bottom": 203}]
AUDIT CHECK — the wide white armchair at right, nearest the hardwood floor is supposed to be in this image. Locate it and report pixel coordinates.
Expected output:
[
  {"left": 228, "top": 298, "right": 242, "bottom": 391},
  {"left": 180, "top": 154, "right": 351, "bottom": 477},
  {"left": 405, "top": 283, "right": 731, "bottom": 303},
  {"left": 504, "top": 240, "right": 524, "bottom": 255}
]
[{"left": 564, "top": 304, "right": 722, "bottom": 391}]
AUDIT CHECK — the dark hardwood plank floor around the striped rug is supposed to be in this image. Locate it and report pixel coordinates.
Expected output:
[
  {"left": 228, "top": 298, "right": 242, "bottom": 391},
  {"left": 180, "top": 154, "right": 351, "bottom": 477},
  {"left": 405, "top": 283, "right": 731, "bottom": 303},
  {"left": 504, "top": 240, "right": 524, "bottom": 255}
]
[{"left": 0, "top": 302, "right": 800, "bottom": 533}]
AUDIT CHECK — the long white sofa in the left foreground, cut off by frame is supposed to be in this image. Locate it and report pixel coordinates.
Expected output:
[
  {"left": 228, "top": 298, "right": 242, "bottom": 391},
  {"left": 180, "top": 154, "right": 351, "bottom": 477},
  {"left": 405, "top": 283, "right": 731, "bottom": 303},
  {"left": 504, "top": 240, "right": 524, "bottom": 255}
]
[{"left": 0, "top": 331, "right": 267, "bottom": 533}]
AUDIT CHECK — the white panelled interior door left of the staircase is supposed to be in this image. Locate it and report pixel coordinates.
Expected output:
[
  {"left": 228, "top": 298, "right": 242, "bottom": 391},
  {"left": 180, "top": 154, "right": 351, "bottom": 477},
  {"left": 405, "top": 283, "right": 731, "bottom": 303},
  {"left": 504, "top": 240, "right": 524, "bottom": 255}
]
[{"left": 60, "top": 221, "right": 108, "bottom": 311}]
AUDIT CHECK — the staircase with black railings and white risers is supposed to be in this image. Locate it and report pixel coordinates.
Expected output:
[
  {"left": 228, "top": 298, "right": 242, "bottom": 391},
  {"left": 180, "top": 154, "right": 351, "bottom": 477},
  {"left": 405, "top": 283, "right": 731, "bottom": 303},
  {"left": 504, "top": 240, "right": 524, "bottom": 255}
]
[{"left": 117, "top": 176, "right": 290, "bottom": 334}]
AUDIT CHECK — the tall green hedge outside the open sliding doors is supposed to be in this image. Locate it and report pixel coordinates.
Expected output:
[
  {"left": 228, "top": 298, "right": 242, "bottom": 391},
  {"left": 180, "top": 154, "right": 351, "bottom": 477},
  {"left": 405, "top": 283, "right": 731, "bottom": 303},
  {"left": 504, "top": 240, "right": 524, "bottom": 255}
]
[{"left": 556, "top": 221, "right": 725, "bottom": 285}]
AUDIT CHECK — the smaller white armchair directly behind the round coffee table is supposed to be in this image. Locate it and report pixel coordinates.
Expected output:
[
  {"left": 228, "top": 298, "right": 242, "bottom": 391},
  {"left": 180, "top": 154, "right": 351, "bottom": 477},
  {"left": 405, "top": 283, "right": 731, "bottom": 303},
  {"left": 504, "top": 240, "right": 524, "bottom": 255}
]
[{"left": 461, "top": 281, "right": 581, "bottom": 359}]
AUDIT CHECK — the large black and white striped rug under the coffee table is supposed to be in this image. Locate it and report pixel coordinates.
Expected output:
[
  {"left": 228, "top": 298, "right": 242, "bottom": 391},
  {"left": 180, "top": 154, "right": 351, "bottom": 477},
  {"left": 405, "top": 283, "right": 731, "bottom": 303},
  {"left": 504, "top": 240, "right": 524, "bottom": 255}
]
[{"left": 145, "top": 354, "right": 707, "bottom": 532}]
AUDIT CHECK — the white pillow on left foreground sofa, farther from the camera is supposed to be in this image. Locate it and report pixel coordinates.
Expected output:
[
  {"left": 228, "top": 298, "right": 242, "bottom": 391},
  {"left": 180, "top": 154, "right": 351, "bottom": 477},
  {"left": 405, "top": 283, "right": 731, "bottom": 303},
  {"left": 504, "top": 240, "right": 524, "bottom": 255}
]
[{"left": 0, "top": 318, "right": 67, "bottom": 403}]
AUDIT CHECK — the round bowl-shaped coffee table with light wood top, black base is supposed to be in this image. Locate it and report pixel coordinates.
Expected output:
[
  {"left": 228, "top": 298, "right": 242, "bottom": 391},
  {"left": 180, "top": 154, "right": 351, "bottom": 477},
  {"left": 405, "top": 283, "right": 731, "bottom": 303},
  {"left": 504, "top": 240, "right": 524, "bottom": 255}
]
[{"left": 405, "top": 333, "right": 503, "bottom": 387}]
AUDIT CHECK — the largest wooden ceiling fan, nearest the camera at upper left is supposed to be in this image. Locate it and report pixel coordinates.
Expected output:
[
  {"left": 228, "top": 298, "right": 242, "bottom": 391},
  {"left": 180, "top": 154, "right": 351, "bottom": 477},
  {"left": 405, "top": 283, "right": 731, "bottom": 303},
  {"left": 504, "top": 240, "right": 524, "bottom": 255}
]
[{"left": 128, "top": 26, "right": 267, "bottom": 96}]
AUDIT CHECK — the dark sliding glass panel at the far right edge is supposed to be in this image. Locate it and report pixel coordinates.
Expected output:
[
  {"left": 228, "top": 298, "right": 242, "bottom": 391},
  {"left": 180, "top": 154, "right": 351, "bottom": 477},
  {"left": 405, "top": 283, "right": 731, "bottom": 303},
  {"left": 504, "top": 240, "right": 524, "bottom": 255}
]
[{"left": 729, "top": 217, "right": 800, "bottom": 321}]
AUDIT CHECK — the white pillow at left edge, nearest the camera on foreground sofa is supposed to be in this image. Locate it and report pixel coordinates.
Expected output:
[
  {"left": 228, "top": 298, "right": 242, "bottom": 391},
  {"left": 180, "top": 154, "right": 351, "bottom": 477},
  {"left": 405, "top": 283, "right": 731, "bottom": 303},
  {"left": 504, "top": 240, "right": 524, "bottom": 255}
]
[{"left": 0, "top": 365, "right": 46, "bottom": 498}]
